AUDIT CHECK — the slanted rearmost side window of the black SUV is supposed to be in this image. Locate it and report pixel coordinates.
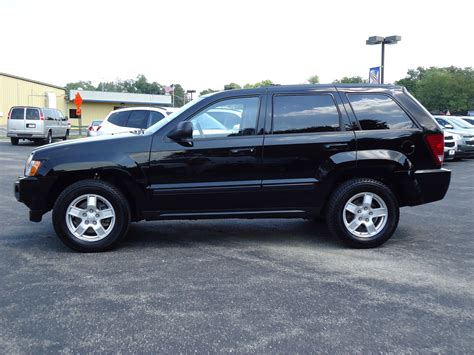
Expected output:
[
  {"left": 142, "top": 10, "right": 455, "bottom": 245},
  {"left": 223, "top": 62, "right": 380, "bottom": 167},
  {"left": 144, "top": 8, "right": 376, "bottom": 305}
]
[{"left": 348, "top": 94, "right": 416, "bottom": 130}]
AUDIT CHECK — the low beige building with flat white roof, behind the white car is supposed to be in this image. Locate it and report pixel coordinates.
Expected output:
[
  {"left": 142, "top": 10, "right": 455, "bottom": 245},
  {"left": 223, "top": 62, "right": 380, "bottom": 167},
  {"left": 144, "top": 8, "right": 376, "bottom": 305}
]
[{"left": 66, "top": 90, "right": 171, "bottom": 126}]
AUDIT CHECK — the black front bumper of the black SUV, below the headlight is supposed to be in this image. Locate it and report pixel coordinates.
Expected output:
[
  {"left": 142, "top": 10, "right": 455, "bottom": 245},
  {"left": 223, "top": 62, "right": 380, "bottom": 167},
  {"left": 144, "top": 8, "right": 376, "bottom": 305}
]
[{"left": 13, "top": 176, "right": 56, "bottom": 222}]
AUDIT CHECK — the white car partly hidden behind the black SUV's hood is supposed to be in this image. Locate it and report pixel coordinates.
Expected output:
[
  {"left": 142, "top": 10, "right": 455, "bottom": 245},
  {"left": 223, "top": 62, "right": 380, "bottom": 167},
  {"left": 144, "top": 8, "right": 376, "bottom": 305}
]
[{"left": 97, "top": 107, "right": 171, "bottom": 136}]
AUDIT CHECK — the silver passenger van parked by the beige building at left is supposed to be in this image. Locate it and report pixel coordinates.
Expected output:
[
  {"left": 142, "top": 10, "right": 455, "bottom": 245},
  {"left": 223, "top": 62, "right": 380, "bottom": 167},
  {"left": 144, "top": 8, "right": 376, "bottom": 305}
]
[{"left": 7, "top": 106, "right": 69, "bottom": 145}]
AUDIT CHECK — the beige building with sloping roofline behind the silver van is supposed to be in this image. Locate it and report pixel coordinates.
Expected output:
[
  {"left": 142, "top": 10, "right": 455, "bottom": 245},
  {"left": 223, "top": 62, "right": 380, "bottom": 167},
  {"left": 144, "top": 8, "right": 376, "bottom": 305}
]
[{"left": 0, "top": 73, "right": 68, "bottom": 126}]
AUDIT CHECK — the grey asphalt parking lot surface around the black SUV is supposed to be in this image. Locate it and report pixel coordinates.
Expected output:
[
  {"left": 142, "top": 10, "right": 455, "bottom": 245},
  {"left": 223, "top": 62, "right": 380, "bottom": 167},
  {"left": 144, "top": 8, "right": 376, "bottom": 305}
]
[{"left": 0, "top": 140, "right": 474, "bottom": 353}]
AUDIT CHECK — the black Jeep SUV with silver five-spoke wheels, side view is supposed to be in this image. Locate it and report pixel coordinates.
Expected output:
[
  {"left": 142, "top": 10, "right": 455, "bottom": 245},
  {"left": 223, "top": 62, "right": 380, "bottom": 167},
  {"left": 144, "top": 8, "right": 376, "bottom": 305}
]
[{"left": 15, "top": 85, "right": 451, "bottom": 251}]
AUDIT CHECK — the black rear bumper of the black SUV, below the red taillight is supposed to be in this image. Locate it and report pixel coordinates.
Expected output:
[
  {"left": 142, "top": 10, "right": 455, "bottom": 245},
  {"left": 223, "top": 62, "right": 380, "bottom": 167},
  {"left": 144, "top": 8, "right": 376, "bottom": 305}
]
[{"left": 403, "top": 169, "right": 451, "bottom": 206}]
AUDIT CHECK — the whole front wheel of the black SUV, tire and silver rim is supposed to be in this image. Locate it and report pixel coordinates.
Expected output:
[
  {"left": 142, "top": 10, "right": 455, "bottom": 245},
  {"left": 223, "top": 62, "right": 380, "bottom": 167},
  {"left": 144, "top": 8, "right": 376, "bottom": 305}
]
[{"left": 53, "top": 180, "right": 130, "bottom": 252}]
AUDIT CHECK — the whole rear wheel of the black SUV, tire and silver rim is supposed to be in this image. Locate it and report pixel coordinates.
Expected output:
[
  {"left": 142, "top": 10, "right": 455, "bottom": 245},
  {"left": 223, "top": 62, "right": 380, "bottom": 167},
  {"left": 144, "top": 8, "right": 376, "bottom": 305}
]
[{"left": 326, "top": 178, "right": 400, "bottom": 248}]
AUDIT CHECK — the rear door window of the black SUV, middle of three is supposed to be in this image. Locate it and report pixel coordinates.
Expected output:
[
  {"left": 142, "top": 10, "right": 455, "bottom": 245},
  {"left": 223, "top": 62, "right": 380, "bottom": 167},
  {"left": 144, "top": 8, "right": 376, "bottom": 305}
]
[{"left": 273, "top": 94, "right": 339, "bottom": 134}]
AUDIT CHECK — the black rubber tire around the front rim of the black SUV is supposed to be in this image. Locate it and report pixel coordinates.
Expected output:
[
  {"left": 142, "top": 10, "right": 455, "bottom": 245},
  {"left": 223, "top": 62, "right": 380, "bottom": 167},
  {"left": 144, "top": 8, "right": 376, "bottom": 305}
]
[{"left": 52, "top": 180, "right": 130, "bottom": 252}]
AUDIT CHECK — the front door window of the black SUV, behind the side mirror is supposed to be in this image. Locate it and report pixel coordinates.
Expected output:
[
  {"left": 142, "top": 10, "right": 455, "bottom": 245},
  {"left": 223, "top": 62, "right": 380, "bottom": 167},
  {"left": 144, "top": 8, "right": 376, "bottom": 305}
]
[{"left": 191, "top": 97, "right": 260, "bottom": 138}]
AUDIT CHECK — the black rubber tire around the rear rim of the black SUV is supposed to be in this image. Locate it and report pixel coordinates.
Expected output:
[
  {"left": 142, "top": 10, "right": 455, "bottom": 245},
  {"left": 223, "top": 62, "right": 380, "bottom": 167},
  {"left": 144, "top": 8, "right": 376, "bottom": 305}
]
[{"left": 326, "top": 178, "right": 400, "bottom": 248}]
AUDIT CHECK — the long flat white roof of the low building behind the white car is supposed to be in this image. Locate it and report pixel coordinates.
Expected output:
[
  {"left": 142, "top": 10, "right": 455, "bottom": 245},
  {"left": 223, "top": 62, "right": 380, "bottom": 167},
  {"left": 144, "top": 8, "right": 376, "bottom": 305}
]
[{"left": 69, "top": 90, "right": 171, "bottom": 105}]
